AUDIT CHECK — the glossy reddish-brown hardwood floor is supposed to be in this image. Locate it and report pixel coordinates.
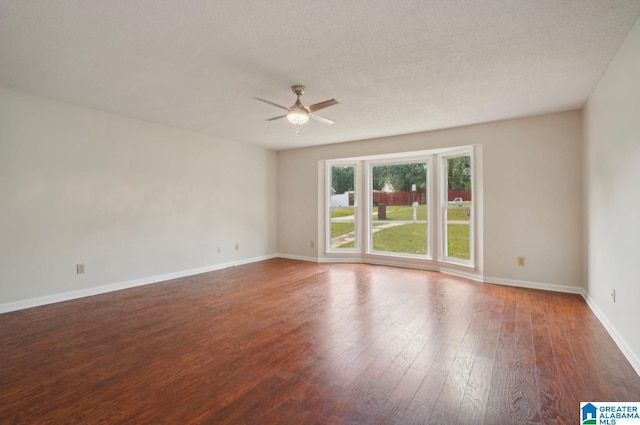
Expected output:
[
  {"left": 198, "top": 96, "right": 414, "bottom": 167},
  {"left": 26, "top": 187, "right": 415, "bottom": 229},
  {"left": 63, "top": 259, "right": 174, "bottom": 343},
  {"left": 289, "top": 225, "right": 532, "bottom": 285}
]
[{"left": 0, "top": 259, "right": 640, "bottom": 425}]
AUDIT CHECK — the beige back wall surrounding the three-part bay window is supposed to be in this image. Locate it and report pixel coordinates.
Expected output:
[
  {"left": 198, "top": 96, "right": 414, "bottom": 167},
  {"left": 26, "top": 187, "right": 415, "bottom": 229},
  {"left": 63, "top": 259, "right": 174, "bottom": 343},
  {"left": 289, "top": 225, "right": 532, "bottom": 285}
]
[{"left": 278, "top": 111, "right": 583, "bottom": 292}]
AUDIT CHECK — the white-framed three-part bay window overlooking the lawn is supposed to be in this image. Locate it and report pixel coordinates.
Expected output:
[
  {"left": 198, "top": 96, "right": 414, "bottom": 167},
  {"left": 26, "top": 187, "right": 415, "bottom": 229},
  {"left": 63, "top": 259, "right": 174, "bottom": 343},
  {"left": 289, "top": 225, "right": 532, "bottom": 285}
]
[{"left": 324, "top": 146, "right": 476, "bottom": 267}]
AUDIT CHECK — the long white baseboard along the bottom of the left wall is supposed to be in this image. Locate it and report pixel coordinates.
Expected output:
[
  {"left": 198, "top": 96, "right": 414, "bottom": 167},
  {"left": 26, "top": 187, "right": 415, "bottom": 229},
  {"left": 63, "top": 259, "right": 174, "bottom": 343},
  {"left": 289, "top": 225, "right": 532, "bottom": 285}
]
[{"left": 0, "top": 254, "right": 278, "bottom": 314}]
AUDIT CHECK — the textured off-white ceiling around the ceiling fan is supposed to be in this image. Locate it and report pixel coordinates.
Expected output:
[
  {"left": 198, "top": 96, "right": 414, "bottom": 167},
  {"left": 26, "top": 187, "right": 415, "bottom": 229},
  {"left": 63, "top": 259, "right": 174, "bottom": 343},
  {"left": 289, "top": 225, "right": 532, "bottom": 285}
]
[{"left": 0, "top": 0, "right": 640, "bottom": 149}]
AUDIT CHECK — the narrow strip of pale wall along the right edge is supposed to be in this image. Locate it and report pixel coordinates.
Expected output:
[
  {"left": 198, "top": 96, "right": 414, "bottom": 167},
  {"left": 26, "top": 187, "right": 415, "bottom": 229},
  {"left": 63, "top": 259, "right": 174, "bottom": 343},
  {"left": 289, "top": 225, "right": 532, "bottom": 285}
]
[{"left": 584, "top": 17, "right": 640, "bottom": 373}]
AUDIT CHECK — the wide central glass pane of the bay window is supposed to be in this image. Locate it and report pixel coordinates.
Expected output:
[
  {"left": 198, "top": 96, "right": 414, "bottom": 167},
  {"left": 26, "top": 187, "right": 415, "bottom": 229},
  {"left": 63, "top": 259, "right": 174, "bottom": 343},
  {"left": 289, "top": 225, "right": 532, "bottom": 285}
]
[{"left": 370, "top": 162, "right": 429, "bottom": 256}]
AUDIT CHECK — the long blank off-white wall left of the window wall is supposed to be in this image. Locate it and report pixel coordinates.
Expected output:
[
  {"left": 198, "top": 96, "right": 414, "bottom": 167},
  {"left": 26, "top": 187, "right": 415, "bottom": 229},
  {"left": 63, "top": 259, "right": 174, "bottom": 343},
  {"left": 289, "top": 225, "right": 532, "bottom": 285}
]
[{"left": 0, "top": 87, "right": 277, "bottom": 310}]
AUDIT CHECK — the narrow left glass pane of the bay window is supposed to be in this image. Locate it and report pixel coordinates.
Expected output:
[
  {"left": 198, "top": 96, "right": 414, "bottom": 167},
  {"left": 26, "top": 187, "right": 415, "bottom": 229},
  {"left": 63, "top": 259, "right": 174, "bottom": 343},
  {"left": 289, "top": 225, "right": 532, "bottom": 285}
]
[{"left": 329, "top": 165, "right": 357, "bottom": 250}]
